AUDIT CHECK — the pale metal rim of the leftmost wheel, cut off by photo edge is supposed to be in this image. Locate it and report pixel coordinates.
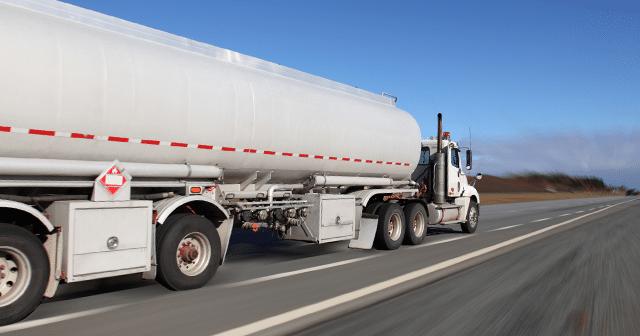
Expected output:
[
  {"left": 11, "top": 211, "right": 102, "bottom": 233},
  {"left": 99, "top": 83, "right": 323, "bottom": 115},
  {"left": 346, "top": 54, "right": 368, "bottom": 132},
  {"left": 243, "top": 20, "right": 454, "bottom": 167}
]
[{"left": 0, "top": 246, "right": 32, "bottom": 307}]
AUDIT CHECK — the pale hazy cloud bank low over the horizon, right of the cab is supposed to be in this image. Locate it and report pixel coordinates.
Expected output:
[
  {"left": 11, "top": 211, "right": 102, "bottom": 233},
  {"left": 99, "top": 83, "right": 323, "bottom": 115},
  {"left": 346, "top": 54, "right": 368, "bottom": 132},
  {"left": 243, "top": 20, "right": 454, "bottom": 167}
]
[{"left": 463, "top": 129, "right": 640, "bottom": 188}]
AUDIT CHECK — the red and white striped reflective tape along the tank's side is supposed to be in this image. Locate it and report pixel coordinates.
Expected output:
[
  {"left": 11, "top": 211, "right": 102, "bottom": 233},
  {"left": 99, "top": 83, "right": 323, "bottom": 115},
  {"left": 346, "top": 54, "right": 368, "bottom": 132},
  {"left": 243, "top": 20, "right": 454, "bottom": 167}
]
[{"left": 0, "top": 126, "right": 410, "bottom": 166}]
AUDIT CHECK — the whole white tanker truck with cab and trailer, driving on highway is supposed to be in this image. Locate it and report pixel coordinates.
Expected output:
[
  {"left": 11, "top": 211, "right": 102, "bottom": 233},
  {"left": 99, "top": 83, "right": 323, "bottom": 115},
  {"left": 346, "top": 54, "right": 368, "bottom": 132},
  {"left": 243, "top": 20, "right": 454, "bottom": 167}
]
[{"left": 0, "top": 0, "right": 480, "bottom": 325}]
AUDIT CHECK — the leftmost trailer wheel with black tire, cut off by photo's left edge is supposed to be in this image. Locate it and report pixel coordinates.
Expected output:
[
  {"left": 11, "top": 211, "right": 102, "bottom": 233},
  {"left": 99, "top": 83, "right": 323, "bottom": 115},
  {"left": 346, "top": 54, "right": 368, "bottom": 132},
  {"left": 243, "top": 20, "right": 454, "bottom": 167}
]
[{"left": 0, "top": 223, "right": 49, "bottom": 325}]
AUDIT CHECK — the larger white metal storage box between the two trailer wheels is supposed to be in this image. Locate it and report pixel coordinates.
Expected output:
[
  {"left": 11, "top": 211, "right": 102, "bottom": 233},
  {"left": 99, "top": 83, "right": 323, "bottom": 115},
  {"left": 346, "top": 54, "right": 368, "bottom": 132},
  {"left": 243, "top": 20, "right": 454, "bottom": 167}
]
[{"left": 47, "top": 201, "right": 153, "bottom": 282}]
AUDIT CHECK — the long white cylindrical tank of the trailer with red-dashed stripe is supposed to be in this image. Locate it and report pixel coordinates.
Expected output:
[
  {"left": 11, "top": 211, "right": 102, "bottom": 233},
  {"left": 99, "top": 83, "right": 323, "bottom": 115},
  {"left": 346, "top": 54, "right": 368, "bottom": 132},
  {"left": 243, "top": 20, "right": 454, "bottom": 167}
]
[{"left": 0, "top": 0, "right": 420, "bottom": 183}]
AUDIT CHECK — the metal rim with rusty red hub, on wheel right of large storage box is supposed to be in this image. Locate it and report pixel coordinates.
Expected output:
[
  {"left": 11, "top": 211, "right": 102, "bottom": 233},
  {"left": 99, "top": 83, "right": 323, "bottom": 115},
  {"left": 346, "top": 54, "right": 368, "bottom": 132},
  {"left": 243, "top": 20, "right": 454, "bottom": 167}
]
[{"left": 176, "top": 232, "right": 211, "bottom": 276}]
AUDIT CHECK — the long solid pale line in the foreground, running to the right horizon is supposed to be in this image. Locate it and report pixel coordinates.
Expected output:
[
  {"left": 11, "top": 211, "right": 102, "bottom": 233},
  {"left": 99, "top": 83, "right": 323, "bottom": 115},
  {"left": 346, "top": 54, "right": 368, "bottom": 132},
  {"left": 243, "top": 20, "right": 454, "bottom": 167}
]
[{"left": 211, "top": 200, "right": 633, "bottom": 336}]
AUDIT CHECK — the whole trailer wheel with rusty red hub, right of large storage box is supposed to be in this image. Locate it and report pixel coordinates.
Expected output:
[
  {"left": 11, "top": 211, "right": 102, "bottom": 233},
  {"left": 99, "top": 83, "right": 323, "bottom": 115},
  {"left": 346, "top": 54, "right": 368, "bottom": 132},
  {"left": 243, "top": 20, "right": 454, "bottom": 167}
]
[{"left": 156, "top": 214, "right": 221, "bottom": 290}]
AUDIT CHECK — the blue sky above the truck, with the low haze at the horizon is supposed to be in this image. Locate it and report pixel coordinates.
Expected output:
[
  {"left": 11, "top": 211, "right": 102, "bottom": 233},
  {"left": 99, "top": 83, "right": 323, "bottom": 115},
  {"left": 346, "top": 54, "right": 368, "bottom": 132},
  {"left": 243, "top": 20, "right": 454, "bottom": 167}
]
[{"left": 64, "top": 0, "right": 640, "bottom": 189}]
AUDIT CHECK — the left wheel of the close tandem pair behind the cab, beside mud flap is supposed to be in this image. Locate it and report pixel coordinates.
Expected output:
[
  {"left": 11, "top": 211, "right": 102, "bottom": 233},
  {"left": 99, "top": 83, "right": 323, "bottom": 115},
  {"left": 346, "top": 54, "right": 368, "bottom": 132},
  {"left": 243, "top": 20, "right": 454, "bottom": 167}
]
[{"left": 374, "top": 203, "right": 405, "bottom": 250}]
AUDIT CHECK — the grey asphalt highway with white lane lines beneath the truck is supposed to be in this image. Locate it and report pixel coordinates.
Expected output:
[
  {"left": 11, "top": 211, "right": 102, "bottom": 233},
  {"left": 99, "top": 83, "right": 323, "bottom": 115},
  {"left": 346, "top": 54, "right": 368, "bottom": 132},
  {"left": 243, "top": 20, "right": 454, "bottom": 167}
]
[{"left": 0, "top": 197, "right": 640, "bottom": 335}]
